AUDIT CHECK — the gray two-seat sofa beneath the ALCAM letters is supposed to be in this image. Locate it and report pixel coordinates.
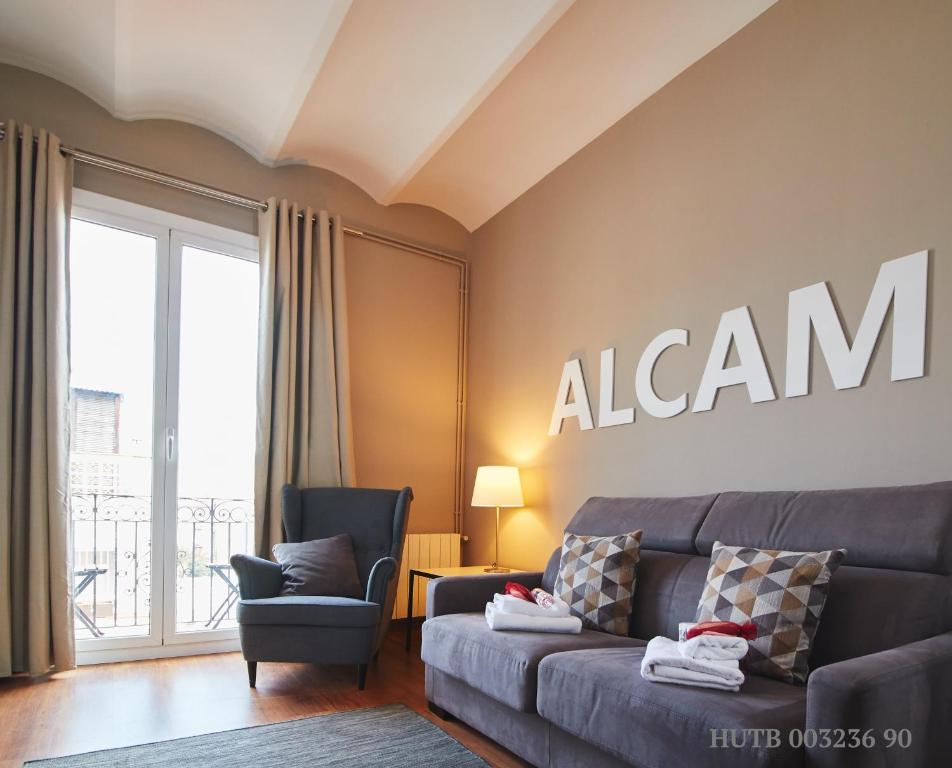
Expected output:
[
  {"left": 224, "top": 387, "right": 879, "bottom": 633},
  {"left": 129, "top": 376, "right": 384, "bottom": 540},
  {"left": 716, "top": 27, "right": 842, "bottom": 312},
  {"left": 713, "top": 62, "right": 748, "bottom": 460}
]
[{"left": 422, "top": 483, "right": 952, "bottom": 768}]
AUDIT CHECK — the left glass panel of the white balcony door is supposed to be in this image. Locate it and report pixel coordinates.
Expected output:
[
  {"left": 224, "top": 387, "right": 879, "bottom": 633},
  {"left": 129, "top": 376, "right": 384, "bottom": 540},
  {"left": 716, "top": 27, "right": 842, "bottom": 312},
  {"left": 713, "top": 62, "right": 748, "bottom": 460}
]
[{"left": 70, "top": 211, "right": 169, "bottom": 651}]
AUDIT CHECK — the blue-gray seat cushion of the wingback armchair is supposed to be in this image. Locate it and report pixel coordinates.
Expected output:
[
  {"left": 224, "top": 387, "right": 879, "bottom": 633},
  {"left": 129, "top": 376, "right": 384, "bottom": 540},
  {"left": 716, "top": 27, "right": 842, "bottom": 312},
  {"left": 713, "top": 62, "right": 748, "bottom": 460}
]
[{"left": 238, "top": 595, "right": 380, "bottom": 627}]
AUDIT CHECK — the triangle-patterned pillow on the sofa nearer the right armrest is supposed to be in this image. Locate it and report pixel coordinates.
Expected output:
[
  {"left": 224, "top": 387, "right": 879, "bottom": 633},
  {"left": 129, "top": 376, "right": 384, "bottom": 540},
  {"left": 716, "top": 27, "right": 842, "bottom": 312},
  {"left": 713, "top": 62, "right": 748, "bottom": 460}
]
[{"left": 697, "top": 541, "right": 846, "bottom": 683}]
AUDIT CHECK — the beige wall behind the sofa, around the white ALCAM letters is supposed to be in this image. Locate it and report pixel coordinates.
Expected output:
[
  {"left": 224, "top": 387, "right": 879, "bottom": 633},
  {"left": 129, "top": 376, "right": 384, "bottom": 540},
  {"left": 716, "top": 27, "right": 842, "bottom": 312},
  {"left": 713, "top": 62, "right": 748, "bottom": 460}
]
[{"left": 467, "top": 0, "right": 952, "bottom": 568}]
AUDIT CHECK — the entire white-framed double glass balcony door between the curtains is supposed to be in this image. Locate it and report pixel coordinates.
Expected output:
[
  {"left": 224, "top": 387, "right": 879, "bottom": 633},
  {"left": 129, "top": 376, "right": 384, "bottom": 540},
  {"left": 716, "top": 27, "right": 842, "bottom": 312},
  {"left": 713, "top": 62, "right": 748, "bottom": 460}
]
[{"left": 70, "top": 190, "right": 258, "bottom": 661}]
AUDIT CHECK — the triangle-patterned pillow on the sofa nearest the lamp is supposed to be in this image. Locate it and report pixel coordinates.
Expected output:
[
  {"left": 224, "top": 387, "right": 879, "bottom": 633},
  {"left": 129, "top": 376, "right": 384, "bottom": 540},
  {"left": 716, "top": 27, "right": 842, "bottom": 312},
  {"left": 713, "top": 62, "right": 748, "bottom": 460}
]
[{"left": 555, "top": 531, "right": 642, "bottom": 635}]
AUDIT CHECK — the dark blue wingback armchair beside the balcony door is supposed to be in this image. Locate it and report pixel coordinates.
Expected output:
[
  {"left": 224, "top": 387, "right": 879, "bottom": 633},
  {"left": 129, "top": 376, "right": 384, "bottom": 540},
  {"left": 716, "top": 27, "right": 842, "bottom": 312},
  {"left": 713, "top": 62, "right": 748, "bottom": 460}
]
[{"left": 231, "top": 485, "right": 413, "bottom": 690}]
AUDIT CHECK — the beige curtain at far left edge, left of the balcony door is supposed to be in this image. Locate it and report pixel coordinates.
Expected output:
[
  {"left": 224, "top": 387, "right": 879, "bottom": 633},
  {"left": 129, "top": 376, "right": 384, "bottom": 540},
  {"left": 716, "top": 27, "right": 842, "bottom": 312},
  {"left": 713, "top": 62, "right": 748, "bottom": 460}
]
[{"left": 0, "top": 121, "right": 74, "bottom": 676}]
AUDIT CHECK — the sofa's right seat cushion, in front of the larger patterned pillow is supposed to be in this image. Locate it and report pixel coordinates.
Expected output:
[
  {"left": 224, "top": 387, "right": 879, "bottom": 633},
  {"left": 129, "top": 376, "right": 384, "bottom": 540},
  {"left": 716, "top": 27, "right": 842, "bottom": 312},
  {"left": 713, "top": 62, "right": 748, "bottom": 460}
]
[{"left": 537, "top": 648, "right": 806, "bottom": 768}]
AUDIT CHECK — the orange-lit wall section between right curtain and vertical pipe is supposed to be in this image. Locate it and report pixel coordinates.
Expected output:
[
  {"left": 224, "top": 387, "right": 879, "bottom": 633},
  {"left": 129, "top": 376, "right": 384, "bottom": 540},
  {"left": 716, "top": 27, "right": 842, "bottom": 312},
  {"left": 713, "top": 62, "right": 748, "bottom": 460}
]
[{"left": 347, "top": 240, "right": 459, "bottom": 533}]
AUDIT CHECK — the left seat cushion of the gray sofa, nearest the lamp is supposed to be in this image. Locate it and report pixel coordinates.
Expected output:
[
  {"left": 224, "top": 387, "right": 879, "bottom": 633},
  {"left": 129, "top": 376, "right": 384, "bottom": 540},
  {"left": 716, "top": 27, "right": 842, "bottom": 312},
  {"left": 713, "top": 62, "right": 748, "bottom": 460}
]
[{"left": 420, "top": 613, "right": 644, "bottom": 712}]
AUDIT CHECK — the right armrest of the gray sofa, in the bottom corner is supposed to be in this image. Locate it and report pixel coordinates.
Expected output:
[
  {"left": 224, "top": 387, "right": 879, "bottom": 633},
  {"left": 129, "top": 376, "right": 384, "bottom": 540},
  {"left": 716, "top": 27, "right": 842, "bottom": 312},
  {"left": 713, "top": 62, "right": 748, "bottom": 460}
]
[{"left": 806, "top": 632, "right": 952, "bottom": 768}]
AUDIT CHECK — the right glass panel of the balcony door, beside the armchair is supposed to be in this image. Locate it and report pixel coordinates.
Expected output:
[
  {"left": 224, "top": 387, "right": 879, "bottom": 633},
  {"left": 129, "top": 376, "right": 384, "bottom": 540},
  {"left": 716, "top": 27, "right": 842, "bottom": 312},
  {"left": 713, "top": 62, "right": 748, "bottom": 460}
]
[{"left": 165, "top": 231, "right": 258, "bottom": 642}]
